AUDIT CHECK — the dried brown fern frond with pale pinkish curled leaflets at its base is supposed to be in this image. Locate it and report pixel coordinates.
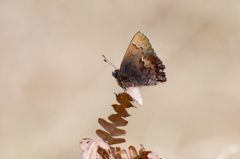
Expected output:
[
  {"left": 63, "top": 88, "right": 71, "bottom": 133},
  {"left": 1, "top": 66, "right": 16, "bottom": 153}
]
[{"left": 80, "top": 93, "right": 160, "bottom": 159}]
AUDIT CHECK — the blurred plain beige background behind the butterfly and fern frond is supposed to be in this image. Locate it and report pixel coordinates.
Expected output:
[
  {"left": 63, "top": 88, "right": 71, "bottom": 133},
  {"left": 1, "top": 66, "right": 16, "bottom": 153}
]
[{"left": 0, "top": 0, "right": 240, "bottom": 159}]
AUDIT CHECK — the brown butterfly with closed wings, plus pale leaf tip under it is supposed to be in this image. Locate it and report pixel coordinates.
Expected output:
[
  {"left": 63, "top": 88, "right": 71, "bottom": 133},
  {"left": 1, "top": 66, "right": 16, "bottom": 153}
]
[{"left": 104, "top": 31, "right": 167, "bottom": 105}]
